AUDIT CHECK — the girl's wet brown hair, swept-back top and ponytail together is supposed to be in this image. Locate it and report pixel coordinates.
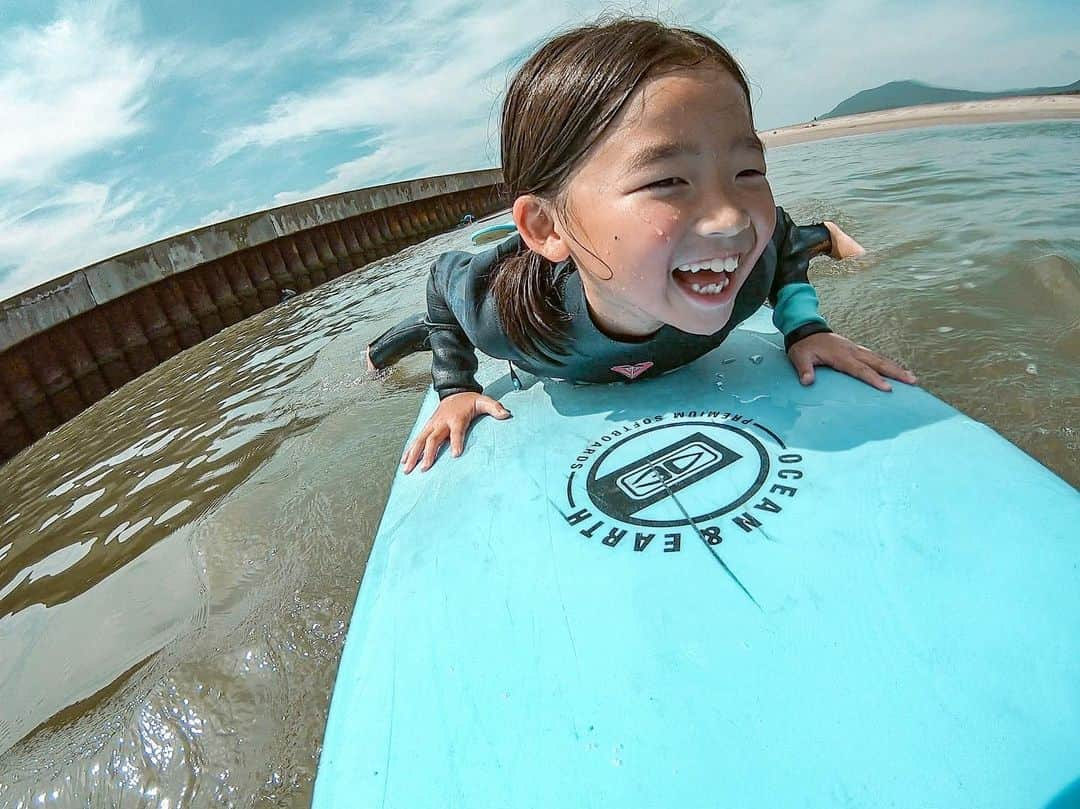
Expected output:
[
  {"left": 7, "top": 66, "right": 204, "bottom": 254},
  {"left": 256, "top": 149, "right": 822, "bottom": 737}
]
[{"left": 491, "top": 17, "right": 752, "bottom": 360}]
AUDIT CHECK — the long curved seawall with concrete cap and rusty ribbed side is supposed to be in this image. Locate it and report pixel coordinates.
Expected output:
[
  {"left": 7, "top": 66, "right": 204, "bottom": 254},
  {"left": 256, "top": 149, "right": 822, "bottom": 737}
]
[{"left": 0, "top": 170, "right": 508, "bottom": 462}]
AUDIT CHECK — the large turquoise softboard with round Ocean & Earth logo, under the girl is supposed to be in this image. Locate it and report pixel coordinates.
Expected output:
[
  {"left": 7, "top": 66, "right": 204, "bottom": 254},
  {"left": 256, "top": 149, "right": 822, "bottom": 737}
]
[{"left": 313, "top": 311, "right": 1080, "bottom": 809}]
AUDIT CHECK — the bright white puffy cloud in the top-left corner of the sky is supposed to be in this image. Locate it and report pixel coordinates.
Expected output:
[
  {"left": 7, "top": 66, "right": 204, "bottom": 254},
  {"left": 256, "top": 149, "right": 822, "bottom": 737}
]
[{"left": 0, "top": 4, "right": 154, "bottom": 187}]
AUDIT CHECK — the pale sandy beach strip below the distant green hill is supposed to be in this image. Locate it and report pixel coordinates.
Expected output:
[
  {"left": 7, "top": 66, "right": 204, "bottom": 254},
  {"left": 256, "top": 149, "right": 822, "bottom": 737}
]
[{"left": 758, "top": 95, "right": 1080, "bottom": 147}]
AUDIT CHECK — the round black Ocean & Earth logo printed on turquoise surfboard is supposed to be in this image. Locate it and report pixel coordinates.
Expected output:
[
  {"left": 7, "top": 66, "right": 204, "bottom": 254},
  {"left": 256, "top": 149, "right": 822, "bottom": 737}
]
[{"left": 563, "top": 410, "right": 804, "bottom": 553}]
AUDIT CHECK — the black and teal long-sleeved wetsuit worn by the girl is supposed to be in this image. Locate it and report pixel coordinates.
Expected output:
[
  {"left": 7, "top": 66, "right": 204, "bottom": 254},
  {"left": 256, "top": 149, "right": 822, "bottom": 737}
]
[{"left": 368, "top": 207, "right": 831, "bottom": 399}]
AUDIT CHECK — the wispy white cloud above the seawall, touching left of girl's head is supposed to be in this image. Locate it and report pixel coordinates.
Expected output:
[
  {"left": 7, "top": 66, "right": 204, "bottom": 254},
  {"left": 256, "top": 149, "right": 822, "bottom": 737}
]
[{"left": 214, "top": 0, "right": 578, "bottom": 198}]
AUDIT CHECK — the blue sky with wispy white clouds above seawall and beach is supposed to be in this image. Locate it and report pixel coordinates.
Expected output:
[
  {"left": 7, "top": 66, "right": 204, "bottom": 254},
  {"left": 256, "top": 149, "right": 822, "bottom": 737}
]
[{"left": 0, "top": 0, "right": 1080, "bottom": 300}]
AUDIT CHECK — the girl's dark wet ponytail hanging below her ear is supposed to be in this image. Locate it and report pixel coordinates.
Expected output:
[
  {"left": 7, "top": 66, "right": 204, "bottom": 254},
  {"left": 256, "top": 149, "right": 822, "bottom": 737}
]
[{"left": 491, "top": 248, "right": 569, "bottom": 362}]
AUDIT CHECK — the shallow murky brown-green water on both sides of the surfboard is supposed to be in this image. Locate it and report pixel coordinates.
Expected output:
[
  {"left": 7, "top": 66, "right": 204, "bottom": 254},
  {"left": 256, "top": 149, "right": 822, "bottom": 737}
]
[{"left": 0, "top": 122, "right": 1080, "bottom": 808}]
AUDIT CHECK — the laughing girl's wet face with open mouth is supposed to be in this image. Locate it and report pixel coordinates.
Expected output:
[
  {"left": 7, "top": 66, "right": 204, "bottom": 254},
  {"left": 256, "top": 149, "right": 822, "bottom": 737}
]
[{"left": 555, "top": 68, "right": 777, "bottom": 336}]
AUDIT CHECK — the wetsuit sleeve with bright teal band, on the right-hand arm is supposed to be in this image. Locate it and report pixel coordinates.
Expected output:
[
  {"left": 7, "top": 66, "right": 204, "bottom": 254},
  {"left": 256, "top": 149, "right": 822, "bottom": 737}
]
[{"left": 769, "top": 207, "right": 833, "bottom": 349}]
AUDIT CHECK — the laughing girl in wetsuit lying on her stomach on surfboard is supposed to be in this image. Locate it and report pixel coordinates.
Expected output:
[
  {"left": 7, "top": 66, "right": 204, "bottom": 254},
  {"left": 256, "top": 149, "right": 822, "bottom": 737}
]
[{"left": 368, "top": 18, "right": 916, "bottom": 472}]
